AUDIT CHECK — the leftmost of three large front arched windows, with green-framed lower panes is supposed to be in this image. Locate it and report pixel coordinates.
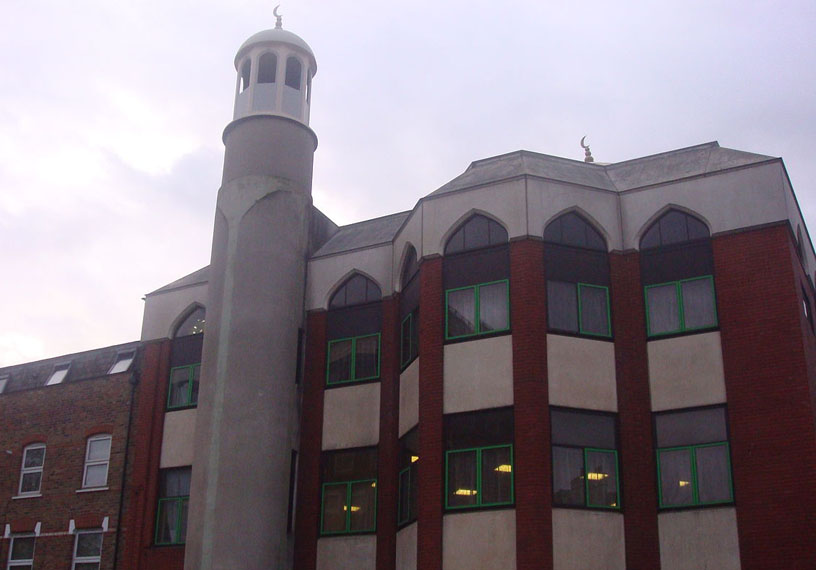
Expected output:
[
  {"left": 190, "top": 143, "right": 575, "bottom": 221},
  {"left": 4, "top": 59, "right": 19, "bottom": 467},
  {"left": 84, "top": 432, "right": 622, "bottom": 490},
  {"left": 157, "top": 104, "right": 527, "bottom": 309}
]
[{"left": 442, "top": 214, "right": 510, "bottom": 340}]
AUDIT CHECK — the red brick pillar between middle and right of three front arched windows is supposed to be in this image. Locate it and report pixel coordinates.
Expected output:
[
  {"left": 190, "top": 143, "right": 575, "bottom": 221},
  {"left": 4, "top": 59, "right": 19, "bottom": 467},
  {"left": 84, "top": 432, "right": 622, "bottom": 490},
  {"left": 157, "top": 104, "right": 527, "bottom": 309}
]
[{"left": 609, "top": 253, "right": 660, "bottom": 569}]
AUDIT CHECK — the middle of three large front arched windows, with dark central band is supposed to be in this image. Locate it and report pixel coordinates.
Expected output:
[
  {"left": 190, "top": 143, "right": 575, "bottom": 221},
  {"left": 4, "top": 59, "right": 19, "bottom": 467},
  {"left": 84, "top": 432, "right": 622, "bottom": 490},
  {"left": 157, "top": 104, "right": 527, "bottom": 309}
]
[{"left": 544, "top": 212, "right": 612, "bottom": 337}]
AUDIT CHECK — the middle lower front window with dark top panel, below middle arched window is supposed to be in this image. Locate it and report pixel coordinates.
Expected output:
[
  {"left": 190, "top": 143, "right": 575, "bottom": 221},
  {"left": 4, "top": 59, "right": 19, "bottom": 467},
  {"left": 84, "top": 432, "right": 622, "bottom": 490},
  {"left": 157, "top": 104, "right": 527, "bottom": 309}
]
[{"left": 550, "top": 408, "right": 620, "bottom": 509}]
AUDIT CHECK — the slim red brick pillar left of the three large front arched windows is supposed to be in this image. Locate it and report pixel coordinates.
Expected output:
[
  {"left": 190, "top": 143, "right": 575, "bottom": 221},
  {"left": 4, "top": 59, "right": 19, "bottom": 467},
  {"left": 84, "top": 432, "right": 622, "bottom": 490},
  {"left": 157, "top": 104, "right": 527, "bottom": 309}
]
[{"left": 417, "top": 257, "right": 445, "bottom": 570}]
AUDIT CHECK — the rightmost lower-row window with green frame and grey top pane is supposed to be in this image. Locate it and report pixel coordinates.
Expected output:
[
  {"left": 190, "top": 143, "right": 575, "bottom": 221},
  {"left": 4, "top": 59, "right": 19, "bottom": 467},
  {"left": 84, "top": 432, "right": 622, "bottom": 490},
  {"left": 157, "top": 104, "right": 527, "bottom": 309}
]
[{"left": 655, "top": 407, "right": 734, "bottom": 508}]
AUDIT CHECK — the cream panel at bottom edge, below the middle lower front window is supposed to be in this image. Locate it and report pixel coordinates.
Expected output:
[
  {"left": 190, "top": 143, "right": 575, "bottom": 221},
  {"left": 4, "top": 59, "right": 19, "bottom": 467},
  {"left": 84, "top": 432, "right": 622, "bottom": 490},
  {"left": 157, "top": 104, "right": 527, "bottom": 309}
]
[{"left": 553, "top": 509, "right": 628, "bottom": 570}]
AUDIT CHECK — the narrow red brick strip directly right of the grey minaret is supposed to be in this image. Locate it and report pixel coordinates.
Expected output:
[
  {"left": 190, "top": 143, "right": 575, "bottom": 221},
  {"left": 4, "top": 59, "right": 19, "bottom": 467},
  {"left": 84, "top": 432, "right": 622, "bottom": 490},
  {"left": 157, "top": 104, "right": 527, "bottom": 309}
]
[{"left": 295, "top": 311, "right": 327, "bottom": 570}]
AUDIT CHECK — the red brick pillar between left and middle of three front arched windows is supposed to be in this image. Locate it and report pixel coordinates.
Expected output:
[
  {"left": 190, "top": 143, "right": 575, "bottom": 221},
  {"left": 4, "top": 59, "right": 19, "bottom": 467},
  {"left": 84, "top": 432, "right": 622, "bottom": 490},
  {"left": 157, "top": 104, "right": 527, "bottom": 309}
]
[{"left": 510, "top": 236, "right": 553, "bottom": 570}]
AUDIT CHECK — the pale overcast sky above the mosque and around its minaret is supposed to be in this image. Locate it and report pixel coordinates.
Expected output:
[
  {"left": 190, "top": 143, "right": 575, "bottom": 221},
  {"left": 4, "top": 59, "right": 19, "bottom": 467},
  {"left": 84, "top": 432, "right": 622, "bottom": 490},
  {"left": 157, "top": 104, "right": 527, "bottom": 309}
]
[{"left": 0, "top": 0, "right": 816, "bottom": 366}]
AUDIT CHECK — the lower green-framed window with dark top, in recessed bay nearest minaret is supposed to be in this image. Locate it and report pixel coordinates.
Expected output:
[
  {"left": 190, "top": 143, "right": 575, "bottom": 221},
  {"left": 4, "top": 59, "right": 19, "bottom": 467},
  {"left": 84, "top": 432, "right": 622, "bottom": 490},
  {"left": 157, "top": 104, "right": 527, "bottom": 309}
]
[{"left": 320, "top": 448, "right": 377, "bottom": 535}]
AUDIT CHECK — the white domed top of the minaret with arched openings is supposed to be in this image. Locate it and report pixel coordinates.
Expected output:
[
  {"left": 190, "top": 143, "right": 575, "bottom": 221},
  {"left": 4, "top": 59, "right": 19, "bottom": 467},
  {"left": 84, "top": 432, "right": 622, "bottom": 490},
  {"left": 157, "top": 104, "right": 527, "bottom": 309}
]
[{"left": 233, "top": 19, "right": 317, "bottom": 125}]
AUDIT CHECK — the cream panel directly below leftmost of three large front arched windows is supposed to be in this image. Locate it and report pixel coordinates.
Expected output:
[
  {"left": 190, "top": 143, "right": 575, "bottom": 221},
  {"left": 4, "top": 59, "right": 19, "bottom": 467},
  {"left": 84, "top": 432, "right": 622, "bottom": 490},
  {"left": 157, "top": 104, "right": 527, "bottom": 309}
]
[{"left": 444, "top": 335, "right": 513, "bottom": 414}]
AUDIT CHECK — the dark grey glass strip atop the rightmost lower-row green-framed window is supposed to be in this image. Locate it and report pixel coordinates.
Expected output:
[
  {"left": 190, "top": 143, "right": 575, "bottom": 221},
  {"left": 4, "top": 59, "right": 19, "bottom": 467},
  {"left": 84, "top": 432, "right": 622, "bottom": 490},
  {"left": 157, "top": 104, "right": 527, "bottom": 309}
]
[{"left": 655, "top": 408, "right": 728, "bottom": 447}]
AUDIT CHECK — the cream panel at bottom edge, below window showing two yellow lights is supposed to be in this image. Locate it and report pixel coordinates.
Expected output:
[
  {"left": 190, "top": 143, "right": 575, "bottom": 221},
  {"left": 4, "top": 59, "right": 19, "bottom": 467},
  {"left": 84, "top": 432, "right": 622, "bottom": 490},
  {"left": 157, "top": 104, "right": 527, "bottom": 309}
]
[{"left": 442, "top": 509, "right": 516, "bottom": 570}]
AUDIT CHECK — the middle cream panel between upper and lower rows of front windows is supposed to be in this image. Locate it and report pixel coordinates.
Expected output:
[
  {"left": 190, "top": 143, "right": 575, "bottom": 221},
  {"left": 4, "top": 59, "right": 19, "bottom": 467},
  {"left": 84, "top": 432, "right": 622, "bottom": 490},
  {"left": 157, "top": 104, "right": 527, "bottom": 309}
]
[{"left": 547, "top": 334, "right": 618, "bottom": 412}]
